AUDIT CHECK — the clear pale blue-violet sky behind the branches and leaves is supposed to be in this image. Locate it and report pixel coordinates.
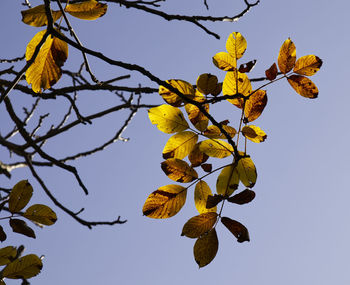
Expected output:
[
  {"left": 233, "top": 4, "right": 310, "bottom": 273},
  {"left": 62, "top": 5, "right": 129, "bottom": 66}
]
[{"left": 0, "top": 0, "right": 350, "bottom": 285}]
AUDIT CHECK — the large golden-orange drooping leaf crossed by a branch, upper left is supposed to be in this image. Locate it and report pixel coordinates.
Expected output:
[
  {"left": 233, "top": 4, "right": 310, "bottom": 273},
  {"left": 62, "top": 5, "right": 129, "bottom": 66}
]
[{"left": 26, "top": 30, "right": 68, "bottom": 93}]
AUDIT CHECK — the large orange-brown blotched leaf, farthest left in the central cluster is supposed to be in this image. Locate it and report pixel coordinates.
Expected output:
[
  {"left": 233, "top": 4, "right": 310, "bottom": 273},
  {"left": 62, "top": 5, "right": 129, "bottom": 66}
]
[{"left": 142, "top": 185, "right": 187, "bottom": 219}]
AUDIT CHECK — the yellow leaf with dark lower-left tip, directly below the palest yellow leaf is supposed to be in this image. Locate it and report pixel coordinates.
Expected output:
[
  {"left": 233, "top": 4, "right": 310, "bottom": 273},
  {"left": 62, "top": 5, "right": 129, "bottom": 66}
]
[{"left": 163, "top": 131, "right": 198, "bottom": 159}]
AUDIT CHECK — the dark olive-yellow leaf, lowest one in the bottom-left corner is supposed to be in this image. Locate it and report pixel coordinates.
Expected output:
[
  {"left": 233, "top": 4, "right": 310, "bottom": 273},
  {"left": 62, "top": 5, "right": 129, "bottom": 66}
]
[{"left": 2, "top": 254, "right": 43, "bottom": 279}]
